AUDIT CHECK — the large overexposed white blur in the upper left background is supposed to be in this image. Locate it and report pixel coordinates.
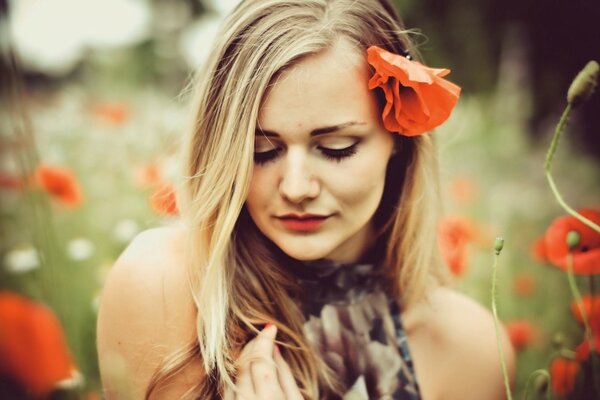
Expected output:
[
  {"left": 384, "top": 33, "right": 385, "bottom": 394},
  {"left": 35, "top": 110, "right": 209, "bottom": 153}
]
[{"left": 10, "top": 0, "right": 151, "bottom": 75}]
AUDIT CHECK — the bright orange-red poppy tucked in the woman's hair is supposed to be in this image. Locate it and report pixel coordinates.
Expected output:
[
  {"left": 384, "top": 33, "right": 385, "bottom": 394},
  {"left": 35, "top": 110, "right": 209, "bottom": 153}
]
[{"left": 367, "top": 46, "right": 460, "bottom": 136}]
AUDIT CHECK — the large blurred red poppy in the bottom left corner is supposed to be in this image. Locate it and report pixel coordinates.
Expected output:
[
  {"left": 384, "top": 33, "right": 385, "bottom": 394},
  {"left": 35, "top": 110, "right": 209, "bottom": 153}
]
[{"left": 0, "top": 292, "right": 74, "bottom": 396}]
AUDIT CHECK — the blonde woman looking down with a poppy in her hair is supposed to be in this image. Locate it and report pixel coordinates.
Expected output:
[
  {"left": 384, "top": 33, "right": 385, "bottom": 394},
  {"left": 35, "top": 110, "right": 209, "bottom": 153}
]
[{"left": 98, "top": 0, "right": 513, "bottom": 400}]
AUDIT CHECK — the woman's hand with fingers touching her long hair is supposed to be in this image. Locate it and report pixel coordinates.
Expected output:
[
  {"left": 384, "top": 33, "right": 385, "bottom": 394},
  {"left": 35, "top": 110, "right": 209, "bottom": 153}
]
[{"left": 224, "top": 324, "right": 302, "bottom": 400}]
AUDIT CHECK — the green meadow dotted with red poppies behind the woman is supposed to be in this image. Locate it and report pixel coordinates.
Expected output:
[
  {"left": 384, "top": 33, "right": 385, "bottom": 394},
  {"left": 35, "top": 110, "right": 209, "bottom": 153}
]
[{"left": 0, "top": 0, "right": 600, "bottom": 400}]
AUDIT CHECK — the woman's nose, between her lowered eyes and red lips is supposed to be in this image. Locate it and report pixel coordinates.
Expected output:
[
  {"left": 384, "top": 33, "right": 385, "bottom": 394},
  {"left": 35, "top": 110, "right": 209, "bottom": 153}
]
[{"left": 279, "top": 149, "right": 321, "bottom": 204}]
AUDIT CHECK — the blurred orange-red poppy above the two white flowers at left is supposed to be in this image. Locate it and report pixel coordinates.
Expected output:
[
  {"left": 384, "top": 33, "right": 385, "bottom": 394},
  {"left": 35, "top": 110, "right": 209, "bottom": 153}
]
[{"left": 36, "top": 165, "right": 83, "bottom": 208}]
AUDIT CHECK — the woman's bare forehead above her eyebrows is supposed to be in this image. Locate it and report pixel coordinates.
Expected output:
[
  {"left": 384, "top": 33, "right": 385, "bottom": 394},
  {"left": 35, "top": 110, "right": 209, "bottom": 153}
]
[{"left": 258, "top": 41, "right": 377, "bottom": 135}]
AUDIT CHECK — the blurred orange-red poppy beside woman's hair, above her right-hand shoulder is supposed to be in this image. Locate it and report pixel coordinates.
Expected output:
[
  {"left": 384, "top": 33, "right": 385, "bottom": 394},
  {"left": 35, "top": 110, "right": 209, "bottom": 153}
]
[{"left": 438, "top": 216, "right": 475, "bottom": 276}]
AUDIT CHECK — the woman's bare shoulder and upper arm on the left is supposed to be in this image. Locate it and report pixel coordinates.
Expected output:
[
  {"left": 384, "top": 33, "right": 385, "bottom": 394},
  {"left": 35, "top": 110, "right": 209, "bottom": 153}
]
[{"left": 97, "top": 227, "right": 203, "bottom": 399}]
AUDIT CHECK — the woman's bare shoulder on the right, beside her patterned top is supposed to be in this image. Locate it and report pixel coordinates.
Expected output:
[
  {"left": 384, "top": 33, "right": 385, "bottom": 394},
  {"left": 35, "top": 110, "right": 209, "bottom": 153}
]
[{"left": 403, "top": 287, "right": 515, "bottom": 400}]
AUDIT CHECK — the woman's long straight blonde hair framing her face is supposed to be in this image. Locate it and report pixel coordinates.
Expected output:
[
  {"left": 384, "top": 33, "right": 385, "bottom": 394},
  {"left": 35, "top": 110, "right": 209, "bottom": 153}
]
[{"left": 146, "top": 0, "right": 442, "bottom": 399}]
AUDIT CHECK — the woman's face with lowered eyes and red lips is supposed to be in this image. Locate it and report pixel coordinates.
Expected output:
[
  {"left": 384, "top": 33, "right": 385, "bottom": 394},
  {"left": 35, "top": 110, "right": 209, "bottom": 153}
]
[{"left": 246, "top": 41, "right": 394, "bottom": 262}]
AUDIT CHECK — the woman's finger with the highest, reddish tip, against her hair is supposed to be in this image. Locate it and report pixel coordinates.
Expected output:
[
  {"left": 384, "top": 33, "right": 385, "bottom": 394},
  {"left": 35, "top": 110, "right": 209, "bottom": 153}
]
[{"left": 250, "top": 325, "right": 284, "bottom": 399}]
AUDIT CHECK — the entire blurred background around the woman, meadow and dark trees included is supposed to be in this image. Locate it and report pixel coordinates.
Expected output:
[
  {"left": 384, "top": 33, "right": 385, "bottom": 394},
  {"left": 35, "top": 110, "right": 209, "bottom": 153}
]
[{"left": 0, "top": 0, "right": 600, "bottom": 399}]
